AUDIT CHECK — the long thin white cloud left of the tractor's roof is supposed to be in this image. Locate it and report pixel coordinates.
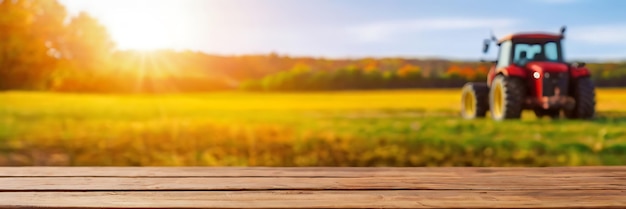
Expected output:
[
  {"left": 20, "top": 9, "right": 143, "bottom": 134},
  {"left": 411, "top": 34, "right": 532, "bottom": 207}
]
[{"left": 348, "top": 17, "right": 519, "bottom": 42}]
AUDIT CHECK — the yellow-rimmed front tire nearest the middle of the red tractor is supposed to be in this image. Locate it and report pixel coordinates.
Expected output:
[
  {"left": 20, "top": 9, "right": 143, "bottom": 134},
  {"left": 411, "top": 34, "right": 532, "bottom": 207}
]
[{"left": 489, "top": 75, "right": 526, "bottom": 121}]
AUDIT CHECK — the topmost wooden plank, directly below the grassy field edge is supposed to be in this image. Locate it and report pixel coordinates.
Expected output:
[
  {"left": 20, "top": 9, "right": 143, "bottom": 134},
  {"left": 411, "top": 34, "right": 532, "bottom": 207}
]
[{"left": 0, "top": 166, "right": 626, "bottom": 178}]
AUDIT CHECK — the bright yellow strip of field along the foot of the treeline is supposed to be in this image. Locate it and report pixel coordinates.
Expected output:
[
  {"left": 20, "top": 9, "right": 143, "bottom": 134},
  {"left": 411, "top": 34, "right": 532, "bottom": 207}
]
[{"left": 0, "top": 89, "right": 626, "bottom": 112}]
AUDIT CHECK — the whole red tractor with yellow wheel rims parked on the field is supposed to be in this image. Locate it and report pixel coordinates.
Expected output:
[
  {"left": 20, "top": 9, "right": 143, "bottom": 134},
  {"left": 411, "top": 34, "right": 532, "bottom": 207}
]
[{"left": 461, "top": 27, "right": 596, "bottom": 120}]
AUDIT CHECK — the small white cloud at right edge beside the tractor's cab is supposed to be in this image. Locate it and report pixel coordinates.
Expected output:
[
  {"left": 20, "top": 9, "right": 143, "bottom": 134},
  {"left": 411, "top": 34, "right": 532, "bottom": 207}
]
[{"left": 567, "top": 25, "right": 626, "bottom": 45}]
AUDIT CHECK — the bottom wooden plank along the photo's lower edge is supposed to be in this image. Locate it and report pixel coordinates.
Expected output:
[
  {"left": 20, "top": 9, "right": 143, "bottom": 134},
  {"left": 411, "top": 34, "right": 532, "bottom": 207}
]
[{"left": 0, "top": 190, "right": 626, "bottom": 208}]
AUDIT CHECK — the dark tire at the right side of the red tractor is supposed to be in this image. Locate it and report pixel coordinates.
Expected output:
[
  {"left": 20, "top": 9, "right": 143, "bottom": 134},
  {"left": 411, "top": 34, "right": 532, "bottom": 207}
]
[{"left": 565, "top": 77, "right": 596, "bottom": 119}]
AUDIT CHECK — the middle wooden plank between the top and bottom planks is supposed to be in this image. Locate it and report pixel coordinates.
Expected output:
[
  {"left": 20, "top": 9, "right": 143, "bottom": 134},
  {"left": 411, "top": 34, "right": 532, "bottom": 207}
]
[{"left": 0, "top": 176, "right": 626, "bottom": 191}]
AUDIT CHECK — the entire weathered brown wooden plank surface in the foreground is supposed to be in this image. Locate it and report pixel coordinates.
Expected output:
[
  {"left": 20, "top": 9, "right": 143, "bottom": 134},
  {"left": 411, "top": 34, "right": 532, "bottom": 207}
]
[{"left": 0, "top": 167, "right": 626, "bottom": 208}]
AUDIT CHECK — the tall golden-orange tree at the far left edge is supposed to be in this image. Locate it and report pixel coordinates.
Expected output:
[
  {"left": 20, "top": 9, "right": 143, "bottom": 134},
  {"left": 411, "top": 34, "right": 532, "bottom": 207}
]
[{"left": 0, "top": 0, "right": 67, "bottom": 90}]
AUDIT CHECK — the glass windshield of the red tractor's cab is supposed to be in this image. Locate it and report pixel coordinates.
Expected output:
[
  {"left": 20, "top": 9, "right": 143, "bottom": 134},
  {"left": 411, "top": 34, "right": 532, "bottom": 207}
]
[{"left": 513, "top": 41, "right": 563, "bottom": 66}]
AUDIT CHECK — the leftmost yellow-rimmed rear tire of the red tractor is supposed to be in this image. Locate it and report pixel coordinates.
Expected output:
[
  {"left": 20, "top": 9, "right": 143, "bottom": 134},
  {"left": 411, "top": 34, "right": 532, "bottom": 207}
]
[{"left": 461, "top": 83, "right": 489, "bottom": 119}]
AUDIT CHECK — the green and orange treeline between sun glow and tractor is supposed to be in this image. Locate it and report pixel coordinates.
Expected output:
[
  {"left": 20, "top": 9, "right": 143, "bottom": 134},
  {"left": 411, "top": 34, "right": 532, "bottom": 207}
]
[{"left": 241, "top": 59, "right": 488, "bottom": 91}]
